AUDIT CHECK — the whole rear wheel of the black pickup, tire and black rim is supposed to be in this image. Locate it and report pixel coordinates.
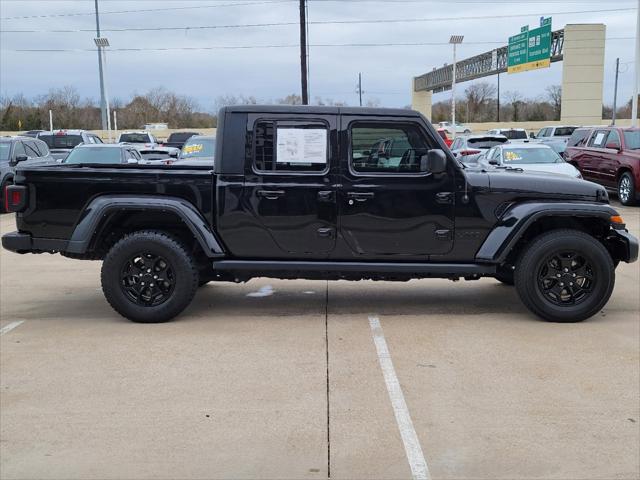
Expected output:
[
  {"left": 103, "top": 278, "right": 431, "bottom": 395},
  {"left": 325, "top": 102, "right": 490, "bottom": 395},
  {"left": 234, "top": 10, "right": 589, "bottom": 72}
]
[{"left": 101, "top": 230, "right": 198, "bottom": 323}]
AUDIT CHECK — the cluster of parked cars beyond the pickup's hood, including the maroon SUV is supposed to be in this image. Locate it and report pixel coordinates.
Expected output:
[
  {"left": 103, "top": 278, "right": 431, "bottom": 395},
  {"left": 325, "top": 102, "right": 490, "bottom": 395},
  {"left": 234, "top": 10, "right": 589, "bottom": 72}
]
[{"left": 438, "top": 126, "right": 640, "bottom": 205}]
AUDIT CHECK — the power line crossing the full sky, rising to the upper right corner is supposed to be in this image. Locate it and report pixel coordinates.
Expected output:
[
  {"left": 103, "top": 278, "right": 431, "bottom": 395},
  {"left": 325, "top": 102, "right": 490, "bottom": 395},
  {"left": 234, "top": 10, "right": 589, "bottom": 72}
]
[{"left": 2, "top": 8, "right": 636, "bottom": 33}]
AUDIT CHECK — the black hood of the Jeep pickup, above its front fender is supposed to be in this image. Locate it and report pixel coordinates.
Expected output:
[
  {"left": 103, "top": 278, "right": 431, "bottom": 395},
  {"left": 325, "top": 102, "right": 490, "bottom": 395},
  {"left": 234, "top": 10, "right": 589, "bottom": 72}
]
[{"left": 486, "top": 169, "right": 608, "bottom": 202}]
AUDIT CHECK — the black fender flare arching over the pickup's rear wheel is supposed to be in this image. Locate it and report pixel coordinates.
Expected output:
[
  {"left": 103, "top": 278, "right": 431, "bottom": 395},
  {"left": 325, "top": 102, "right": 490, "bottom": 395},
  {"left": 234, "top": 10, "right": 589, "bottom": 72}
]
[{"left": 65, "top": 195, "right": 225, "bottom": 258}]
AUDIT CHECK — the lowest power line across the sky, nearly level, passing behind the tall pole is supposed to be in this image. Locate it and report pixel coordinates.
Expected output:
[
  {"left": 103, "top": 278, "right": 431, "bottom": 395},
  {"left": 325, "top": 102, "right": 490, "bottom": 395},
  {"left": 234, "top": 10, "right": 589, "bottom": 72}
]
[{"left": 8, "top": 37, "right": 635, "bottom": 52}]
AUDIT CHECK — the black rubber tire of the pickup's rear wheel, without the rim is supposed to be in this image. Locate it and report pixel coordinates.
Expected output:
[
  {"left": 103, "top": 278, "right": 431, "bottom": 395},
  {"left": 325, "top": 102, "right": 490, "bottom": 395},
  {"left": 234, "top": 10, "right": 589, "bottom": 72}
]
[{"left": 101, "top": 230, "right": 199, "bottom": 323}]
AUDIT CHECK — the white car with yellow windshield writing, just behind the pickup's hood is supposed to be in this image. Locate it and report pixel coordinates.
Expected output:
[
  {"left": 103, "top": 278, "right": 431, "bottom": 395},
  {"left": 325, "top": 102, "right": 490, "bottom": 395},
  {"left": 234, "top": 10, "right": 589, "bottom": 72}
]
[{"left": 478, "top": 143, "right": 582, "bottom": 178}]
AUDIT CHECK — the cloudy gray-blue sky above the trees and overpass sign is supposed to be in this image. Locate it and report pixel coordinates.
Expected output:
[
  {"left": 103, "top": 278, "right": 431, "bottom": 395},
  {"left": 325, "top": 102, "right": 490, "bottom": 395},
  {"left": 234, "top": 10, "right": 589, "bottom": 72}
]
[{"left": 0, "top": 0, "right": 637, "bottom": 110}]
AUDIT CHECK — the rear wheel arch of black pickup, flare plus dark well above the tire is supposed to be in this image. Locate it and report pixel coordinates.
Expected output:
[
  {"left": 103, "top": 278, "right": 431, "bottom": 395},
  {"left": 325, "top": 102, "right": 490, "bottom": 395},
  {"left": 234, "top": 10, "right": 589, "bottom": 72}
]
[{"left": 66, "top": 195, "right": 225, "bottom": 258}]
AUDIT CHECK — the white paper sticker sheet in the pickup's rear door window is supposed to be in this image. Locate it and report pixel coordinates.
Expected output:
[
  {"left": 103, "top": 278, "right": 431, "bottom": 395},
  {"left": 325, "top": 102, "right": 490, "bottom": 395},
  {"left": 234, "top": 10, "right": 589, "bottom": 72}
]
[{"left": 276, "top": 128, "right": 327, "bottom": 164}]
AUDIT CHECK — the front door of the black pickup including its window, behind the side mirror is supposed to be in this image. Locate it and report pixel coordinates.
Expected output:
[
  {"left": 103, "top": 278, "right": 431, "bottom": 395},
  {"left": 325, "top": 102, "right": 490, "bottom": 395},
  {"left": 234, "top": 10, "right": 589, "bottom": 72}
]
[{"left": 338, "top": 116, "right": 455, "bottom": 260}]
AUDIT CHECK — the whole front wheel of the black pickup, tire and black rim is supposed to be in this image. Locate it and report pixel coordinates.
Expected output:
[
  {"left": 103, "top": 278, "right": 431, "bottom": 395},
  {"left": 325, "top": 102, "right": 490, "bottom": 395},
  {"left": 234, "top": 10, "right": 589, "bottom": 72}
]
[{"left": 515, "top": 230, "right": 615, "bottom": 322}]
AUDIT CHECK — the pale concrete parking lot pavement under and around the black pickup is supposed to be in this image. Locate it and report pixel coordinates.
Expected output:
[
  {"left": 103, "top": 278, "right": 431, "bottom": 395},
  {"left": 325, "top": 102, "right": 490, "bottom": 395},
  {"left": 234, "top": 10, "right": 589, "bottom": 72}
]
[{"left": 0, "top": 205, "right": 640, "bottom": 479}]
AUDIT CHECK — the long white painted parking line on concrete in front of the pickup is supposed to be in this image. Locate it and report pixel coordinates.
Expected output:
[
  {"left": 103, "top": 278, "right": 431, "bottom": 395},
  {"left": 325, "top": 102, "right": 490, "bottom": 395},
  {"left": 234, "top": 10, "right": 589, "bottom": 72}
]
[{"left": 369, "top": 317, "right": 431, "bottom": 480}]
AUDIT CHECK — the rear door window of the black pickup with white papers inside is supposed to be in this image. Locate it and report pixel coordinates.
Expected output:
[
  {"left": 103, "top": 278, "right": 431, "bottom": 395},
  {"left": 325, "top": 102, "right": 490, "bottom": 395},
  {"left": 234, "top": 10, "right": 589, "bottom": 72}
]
[{"left": 253, "top": 119, "right": 330, "bottom": 174}]
